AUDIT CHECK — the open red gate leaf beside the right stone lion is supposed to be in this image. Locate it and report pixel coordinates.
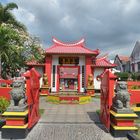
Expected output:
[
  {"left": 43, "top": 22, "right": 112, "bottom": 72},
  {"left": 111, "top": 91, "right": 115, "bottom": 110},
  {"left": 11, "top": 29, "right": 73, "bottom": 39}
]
[{"left": 100, "top": 70, "right": 116, "bottom": 131}]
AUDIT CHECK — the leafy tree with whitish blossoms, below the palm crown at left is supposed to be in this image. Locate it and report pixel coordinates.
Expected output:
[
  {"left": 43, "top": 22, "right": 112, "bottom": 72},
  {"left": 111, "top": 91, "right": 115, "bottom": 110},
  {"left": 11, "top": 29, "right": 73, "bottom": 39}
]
[{"left": 0, "top": 23, "right": 45, "bottom": 79}]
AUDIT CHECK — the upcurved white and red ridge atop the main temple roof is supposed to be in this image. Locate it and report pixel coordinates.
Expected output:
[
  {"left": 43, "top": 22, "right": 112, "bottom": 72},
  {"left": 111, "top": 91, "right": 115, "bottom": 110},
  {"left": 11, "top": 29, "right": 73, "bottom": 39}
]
[{"left": 53, "top": 37, "right": 85, "bottom": 46}]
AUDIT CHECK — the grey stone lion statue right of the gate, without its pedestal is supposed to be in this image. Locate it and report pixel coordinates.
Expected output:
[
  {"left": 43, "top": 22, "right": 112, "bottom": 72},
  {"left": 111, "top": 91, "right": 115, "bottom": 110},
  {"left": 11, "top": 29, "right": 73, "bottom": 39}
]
[{"left": 113, "top": 82, "right": 130, "bottom": 109}]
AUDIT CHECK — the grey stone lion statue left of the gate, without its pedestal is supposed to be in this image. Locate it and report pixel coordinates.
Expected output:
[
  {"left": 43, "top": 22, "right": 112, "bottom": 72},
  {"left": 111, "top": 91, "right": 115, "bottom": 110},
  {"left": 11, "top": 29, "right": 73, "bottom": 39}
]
[{"left": 7, "top": 79, "right": 27, "bottom": 111}]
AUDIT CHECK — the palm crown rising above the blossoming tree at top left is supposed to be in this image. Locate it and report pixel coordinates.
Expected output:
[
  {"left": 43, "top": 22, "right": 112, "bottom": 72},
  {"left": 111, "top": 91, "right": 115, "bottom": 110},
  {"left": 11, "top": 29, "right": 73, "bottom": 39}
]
[{"left": 0, "top": 3, "right": 26, "bottom": 31}]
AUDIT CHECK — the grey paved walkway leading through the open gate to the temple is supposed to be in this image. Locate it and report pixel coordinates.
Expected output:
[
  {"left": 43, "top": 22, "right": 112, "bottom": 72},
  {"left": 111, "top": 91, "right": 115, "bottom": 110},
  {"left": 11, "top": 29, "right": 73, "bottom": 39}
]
[{"left": 22, "top": 97, "right": 127, "bottom": 140}]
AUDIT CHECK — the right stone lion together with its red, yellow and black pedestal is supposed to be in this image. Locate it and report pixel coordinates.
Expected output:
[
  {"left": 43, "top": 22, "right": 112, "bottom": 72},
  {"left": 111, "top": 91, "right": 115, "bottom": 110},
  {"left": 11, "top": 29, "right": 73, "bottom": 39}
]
[{"left": 109, "top": 82, "right": 138, "bottom": 137}]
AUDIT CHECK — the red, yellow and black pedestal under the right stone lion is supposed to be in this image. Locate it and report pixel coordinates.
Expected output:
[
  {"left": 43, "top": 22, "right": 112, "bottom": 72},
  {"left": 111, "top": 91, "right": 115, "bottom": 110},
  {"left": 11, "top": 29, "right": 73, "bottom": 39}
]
[{"left": 110, "top": 109, "right": 138, "bottom": 137}]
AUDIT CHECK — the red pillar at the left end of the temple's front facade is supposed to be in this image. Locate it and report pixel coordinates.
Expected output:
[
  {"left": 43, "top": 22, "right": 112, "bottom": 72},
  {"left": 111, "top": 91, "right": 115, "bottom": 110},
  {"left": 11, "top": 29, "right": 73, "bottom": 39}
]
[{"left": 45, "top": 55, "right": 52, "bottom": 87}]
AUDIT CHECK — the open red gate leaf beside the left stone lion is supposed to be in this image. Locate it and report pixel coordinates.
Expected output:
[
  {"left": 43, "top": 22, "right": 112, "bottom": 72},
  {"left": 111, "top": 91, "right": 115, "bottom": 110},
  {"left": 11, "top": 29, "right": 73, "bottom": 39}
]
[{"left": 24, "top": 68, "right": 41, "bottom": 129}]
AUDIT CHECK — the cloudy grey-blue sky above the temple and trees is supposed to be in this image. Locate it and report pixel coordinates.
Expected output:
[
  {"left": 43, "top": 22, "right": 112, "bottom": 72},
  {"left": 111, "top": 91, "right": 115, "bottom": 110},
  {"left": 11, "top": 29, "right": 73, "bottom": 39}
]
[{"left": 0, "top": 0, "right": 140, "bottom": 57}]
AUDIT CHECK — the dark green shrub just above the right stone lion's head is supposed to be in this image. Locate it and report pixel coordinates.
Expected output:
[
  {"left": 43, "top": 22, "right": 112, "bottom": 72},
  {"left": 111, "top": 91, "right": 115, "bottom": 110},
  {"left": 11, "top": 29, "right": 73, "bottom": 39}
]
[{"left": 115, "top": 72, "right": 130, "bottom": 81}]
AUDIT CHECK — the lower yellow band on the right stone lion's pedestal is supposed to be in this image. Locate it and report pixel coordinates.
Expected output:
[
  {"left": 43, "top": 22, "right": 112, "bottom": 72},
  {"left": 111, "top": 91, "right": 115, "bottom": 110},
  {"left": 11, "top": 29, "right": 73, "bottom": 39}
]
[{"left": 111, "top": 124, "right": 138, "bottom": 130}]
